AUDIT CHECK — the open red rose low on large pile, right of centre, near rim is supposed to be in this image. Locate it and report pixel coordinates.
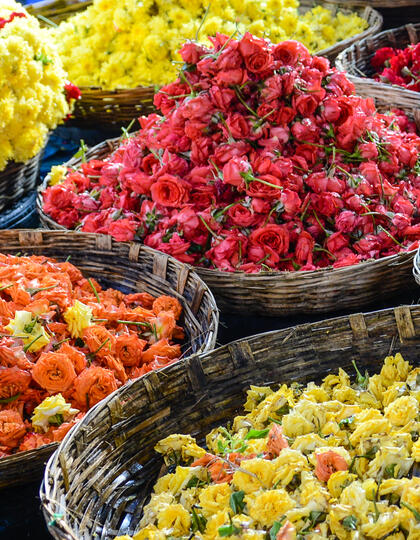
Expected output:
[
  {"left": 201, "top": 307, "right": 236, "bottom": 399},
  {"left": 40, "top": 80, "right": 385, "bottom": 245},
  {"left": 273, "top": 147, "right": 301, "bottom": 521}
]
[{"left": 249, "top": 224, "right": 289, "bottom": 266}]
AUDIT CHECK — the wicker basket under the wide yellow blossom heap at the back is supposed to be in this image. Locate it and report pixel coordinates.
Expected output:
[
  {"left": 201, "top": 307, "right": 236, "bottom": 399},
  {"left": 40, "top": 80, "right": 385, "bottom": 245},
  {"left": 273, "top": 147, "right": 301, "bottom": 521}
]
[{"left": 28, "top": 0, "right": 383, "bottom": 127}]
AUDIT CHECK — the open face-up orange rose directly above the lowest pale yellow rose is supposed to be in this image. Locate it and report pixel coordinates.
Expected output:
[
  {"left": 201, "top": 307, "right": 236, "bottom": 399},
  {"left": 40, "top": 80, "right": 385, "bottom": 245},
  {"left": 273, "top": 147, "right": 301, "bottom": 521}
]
[{"left": 32, "top": 352, "right": 76, "bottom": 392}]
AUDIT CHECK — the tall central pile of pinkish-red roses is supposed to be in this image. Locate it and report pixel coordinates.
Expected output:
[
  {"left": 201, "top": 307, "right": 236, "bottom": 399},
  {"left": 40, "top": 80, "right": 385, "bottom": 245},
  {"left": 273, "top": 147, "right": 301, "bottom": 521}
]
[{"left": 43, "top": 34, "right": 420, "bottom": 272}]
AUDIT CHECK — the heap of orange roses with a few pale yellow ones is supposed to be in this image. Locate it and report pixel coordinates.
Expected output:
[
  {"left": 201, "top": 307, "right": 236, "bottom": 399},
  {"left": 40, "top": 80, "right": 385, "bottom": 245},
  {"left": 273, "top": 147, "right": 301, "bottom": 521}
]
[{"left": 0, "top": 254, "right": 184, "bottom": 458}]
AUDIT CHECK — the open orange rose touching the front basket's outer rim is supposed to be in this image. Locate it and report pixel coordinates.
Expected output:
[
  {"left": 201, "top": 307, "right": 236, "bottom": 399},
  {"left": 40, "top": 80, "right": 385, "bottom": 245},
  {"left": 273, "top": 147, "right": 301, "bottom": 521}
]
[{"left": 74, "top": 366, "right": 118, "bottom": 410}]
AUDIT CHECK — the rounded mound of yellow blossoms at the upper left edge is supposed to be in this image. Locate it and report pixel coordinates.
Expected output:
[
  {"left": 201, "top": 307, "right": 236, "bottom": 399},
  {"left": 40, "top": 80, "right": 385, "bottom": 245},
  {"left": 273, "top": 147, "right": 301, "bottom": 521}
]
[{"left": 0, "top": 0, "right": 70, "bottom": 171}]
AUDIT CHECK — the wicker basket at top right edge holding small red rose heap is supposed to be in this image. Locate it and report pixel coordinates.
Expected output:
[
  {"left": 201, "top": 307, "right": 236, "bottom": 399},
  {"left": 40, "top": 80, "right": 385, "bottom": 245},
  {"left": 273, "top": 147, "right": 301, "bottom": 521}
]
[{"left": 336, "top": 22, "right": 420, "bottom": 128}]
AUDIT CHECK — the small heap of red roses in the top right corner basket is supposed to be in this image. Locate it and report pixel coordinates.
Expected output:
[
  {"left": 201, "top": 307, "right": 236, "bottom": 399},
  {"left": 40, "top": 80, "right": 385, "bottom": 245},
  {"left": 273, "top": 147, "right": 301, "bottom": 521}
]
[{"left": 371, "top": 43, "right": 420, "bottom": 92}]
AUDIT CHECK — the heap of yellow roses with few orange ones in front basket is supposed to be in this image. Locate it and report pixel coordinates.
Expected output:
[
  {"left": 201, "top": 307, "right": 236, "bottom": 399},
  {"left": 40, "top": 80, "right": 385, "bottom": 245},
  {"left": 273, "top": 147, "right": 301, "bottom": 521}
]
[{"left": 118, "top": 354, "right": 420, "bottom": 540}]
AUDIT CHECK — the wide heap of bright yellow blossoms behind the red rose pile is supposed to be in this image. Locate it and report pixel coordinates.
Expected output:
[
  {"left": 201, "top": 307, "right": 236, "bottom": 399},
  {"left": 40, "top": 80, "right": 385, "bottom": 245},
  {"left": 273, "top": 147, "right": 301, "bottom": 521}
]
[{"left": 53, "top": 0, "right": 367, "bottom": 90}]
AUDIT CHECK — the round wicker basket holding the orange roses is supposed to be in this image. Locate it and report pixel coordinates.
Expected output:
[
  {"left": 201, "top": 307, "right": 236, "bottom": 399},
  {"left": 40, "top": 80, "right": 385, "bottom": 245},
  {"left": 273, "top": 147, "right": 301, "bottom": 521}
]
[{"left": 0, "top": 230, "right": 219, "bottom": 489}]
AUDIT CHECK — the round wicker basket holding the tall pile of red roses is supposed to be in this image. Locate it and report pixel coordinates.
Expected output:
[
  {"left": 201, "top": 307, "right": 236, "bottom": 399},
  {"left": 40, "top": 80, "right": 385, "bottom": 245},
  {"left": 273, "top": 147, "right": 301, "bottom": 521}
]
[{"left": 37, "top": 139, "right": 414, "bottom": 317}]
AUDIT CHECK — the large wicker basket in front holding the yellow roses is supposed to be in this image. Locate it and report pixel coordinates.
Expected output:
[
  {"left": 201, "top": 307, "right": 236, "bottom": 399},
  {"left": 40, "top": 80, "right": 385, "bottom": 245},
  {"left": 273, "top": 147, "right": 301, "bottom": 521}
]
[{"left": 41, "top": 306, "right": 420, "bottom": 540}]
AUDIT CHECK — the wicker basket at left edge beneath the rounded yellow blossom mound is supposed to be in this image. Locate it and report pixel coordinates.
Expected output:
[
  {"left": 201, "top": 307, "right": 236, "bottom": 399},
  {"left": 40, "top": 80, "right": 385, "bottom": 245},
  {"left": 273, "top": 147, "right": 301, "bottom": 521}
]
[{"left": 0, "top": 150, "right": 43, "bottom": 212}]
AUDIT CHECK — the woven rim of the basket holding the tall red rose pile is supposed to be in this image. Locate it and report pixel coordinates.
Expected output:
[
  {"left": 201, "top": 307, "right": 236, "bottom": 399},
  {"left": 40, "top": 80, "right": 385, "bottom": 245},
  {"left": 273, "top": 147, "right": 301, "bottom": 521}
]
[{"left": 36, "top": 137, "right": 415, "bottom": 280}]
